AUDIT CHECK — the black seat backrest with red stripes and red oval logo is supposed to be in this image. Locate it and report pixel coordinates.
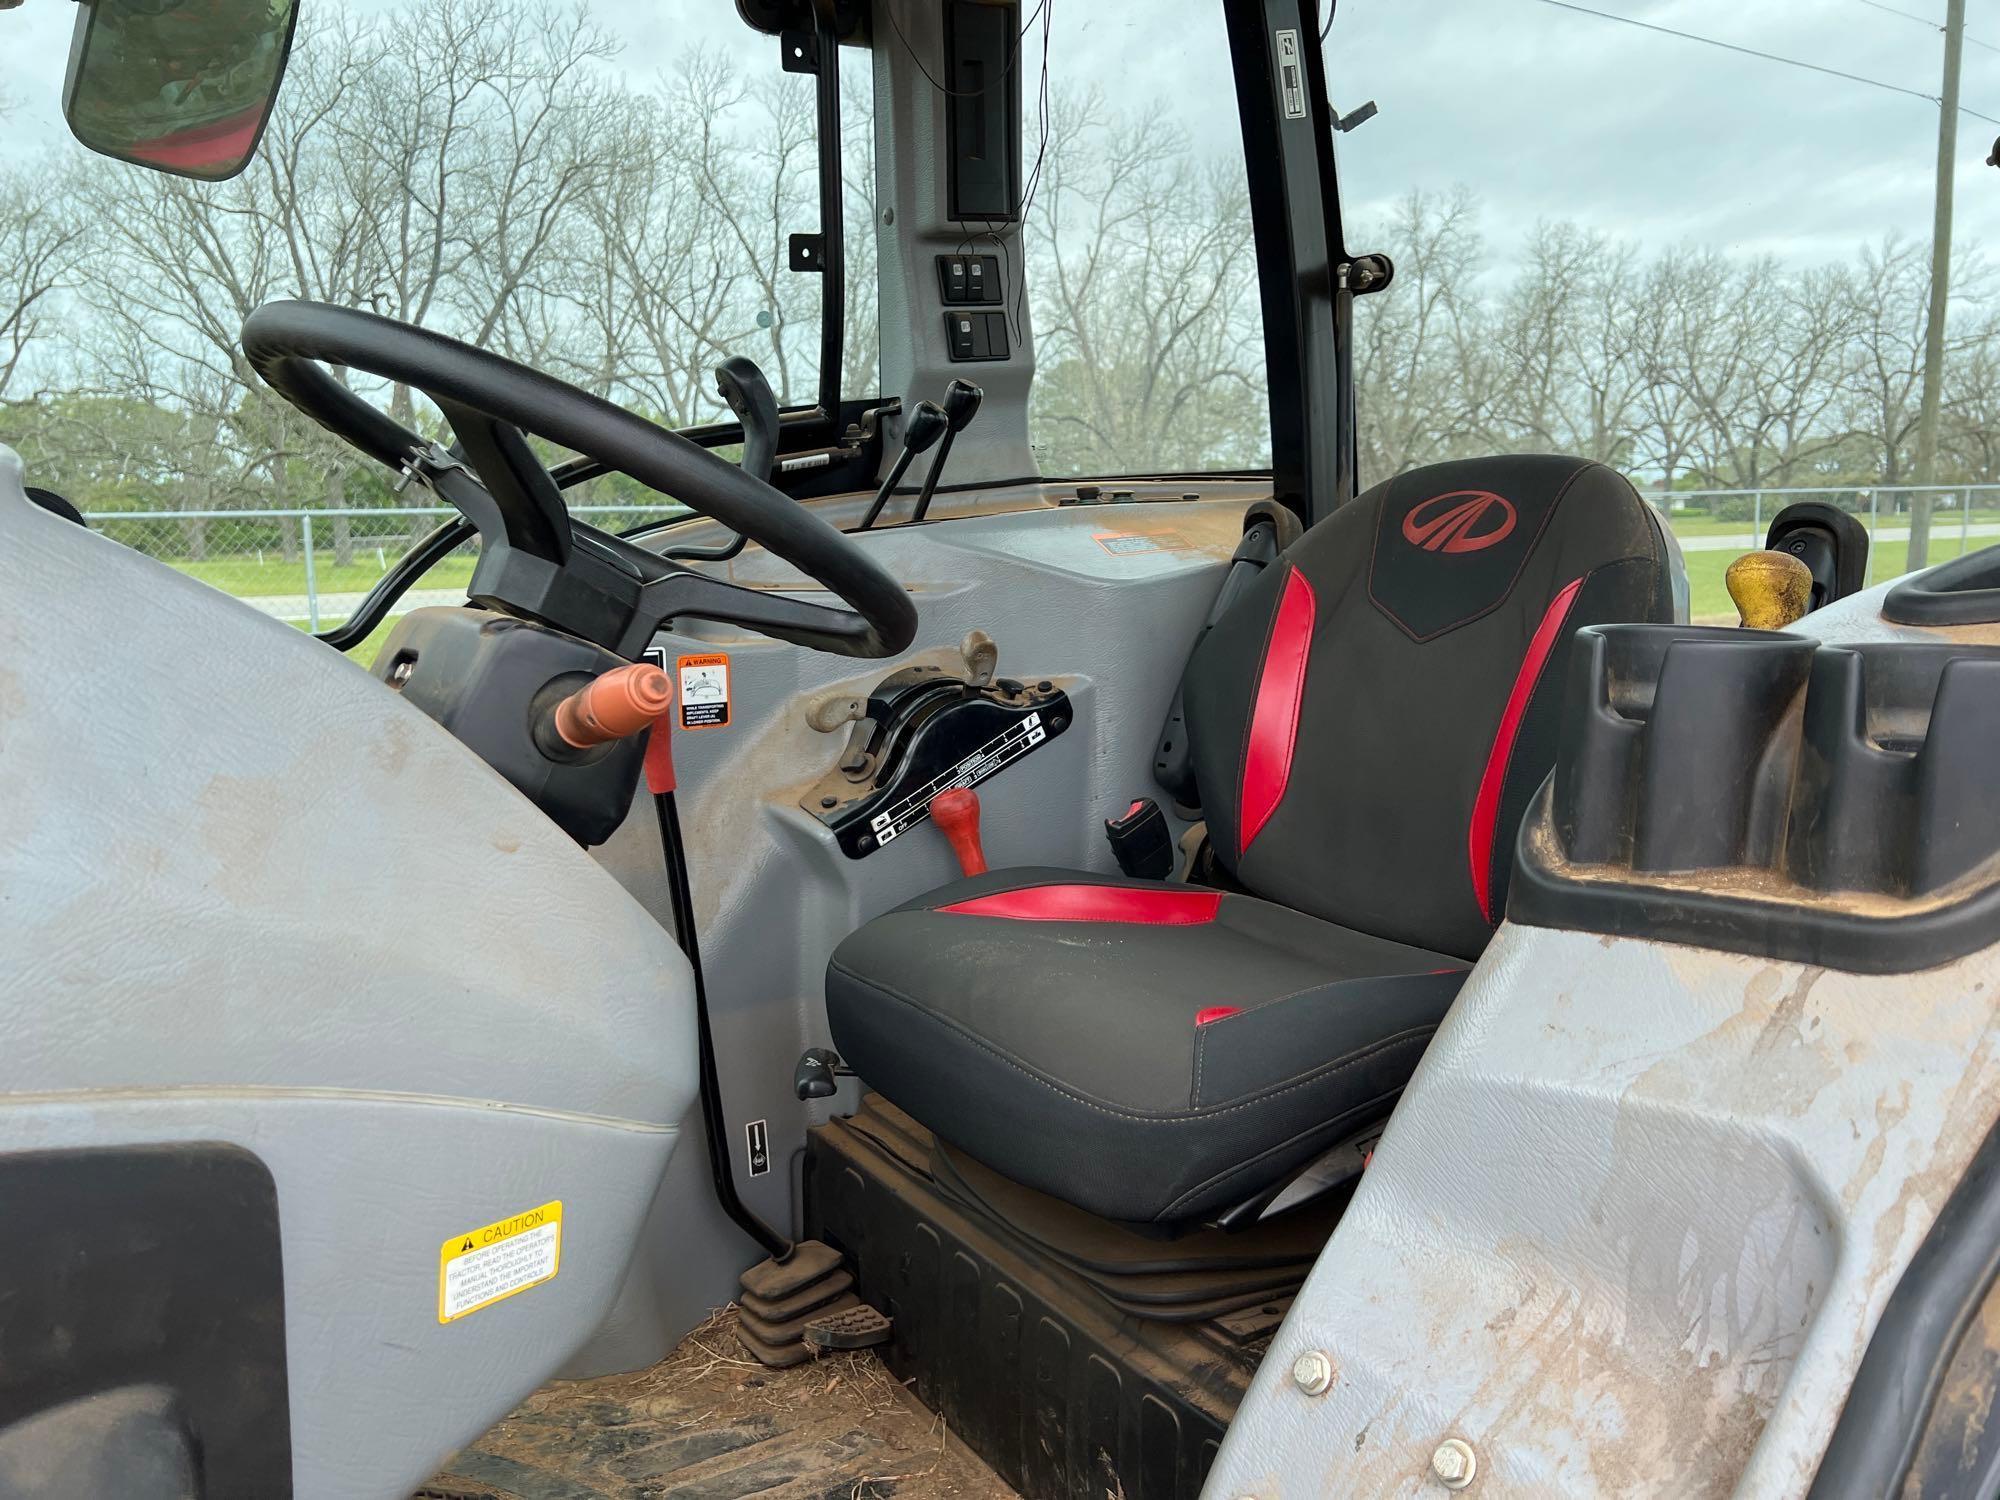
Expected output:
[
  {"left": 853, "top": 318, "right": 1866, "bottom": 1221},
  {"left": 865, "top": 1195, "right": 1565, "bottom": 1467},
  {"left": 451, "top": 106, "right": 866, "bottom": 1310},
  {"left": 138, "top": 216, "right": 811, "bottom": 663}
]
[{"left": 1184, "top": 454, "right": 1678, "bottom": 956}]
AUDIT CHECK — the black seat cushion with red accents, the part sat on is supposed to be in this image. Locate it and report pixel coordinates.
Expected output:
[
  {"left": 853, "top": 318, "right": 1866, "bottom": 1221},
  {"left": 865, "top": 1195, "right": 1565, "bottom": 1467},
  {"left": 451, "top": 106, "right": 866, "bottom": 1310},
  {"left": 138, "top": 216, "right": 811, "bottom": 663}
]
[{"left": 826, "top": 870, "right": 1466, "bottom": 1224}]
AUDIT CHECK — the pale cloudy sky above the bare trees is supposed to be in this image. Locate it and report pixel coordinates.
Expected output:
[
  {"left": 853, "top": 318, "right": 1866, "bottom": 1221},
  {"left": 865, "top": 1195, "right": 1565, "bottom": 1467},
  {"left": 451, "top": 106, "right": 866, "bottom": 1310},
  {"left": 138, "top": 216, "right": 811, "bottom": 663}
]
[{"left": 0, "top": 0, "right": 2000, "bottom": 282}]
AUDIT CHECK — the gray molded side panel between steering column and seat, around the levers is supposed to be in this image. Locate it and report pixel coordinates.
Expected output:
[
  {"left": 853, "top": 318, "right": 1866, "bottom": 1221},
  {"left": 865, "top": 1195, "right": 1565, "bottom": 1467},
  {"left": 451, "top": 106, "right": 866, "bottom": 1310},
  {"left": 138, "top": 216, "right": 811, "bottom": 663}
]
[{"left": 570, "top": 496, "right": 1248, "bottom": 1374}]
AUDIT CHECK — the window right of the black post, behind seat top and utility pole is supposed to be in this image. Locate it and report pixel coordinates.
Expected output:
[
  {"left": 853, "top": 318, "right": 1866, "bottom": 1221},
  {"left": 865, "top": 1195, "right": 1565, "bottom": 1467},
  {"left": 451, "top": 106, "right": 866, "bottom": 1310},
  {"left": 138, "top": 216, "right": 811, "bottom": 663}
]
[{"left": 1326, "top": 0, "right": 2000, "bottom": 622}]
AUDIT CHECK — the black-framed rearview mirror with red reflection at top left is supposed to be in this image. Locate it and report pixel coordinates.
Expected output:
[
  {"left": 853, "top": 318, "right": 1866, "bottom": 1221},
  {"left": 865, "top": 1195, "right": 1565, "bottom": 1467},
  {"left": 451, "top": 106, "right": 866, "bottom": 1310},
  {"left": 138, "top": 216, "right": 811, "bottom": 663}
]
[{"left": 62, "top": 0, "right": 298, "bottom": 182}]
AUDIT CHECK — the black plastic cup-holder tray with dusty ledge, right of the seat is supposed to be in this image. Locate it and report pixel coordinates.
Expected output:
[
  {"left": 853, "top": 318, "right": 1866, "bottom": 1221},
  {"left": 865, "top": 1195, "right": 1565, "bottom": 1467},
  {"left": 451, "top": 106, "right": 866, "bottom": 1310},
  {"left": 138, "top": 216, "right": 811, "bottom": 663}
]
[{"left": 1508, "top": 626, "right": 2000, "bottom": 974}]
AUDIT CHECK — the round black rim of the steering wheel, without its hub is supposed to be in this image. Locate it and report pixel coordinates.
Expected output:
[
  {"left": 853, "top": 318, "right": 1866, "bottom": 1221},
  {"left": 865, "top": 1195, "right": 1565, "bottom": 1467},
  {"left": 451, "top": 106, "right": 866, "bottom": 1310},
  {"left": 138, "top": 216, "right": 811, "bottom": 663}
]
[{"left": 242, "top": 302, "right": 916, "bottom": 656}]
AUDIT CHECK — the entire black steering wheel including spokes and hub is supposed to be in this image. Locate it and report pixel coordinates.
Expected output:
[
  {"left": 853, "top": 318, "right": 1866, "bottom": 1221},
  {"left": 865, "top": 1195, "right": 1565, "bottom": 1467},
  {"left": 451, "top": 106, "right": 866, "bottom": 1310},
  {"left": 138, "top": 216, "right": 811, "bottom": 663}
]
[{"left": 242, "top": 302, "right": 916, "bottom": 660}]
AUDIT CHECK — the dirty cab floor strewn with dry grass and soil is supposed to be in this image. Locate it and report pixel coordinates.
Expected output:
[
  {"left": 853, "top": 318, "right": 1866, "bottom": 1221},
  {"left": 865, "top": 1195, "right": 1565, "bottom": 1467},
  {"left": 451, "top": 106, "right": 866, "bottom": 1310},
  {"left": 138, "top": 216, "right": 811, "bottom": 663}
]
[{"left": 416, "top": 1310, "right": 1018, "bottom": 1500}]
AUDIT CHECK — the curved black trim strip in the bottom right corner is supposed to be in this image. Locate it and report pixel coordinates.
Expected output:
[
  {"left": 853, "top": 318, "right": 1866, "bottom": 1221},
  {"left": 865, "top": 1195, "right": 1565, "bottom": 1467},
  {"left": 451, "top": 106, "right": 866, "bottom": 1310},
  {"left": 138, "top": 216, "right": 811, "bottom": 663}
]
[{"left": 1806, "top": 1126, "right": 2000, "bottom": 1500}]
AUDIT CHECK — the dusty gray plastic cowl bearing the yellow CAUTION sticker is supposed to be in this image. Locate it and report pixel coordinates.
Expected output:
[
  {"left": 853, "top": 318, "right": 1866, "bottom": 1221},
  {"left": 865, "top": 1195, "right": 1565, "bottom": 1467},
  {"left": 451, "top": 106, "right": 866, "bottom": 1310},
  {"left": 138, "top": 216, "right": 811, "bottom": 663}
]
[{"left": 0, "top": 448, "right": 696, "bottom": 1500}]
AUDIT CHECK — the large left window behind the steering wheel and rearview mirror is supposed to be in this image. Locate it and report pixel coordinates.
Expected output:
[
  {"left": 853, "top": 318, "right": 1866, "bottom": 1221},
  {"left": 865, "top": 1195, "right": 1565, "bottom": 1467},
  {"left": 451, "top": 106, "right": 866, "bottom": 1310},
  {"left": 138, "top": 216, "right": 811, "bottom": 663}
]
[{"left": 0, "top": 0, "right": 880, "bottom": 660}]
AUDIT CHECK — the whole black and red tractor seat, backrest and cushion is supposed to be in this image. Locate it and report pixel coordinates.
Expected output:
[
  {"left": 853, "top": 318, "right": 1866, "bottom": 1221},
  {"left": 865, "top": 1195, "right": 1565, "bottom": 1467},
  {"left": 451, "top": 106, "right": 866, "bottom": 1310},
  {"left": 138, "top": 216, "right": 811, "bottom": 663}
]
[{"left": 826, "top": 456, "right": 1674, "bottom": 1224}]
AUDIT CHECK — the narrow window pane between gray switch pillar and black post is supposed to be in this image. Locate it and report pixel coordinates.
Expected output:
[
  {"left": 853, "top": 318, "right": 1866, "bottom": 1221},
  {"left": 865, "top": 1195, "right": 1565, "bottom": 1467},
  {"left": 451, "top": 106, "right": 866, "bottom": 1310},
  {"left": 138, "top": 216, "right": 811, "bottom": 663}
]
[{"left": 1022, "top": 0, "right": 1270, "bottom": 476}]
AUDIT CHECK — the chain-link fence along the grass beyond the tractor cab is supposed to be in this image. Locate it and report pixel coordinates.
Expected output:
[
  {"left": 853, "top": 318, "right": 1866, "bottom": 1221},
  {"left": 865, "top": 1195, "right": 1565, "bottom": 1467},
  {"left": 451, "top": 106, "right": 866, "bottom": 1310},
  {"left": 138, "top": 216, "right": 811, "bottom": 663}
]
[{"left": 88, "top": 484, "right": 2000, "bottom": 640}]
